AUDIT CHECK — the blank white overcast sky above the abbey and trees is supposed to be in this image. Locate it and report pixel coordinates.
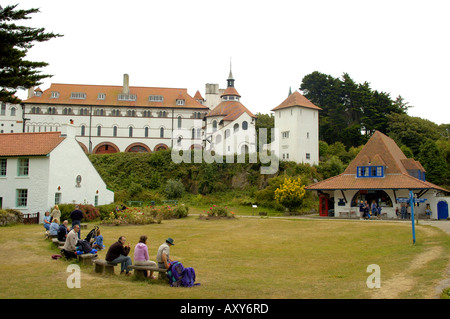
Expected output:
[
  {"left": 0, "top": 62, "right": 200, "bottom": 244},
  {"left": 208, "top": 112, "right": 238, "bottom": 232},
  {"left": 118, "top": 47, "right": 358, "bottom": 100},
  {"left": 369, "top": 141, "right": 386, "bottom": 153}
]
[{"left": 7, "top": 0, "right": 450, "bottom": 124}]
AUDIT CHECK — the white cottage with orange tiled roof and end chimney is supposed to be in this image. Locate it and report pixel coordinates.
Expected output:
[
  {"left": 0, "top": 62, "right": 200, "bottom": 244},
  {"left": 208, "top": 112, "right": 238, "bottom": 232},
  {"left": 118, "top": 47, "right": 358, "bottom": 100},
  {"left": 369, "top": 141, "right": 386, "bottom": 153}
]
[{"left": 0, "top": 124, "right": 114, "bottom": 222}]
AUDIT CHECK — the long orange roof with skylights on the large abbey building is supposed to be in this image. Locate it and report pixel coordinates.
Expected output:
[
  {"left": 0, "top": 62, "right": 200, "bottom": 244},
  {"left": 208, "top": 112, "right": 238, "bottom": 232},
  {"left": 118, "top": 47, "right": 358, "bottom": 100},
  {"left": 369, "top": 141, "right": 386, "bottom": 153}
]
[{"left": 23, "top": 83, "right": 208, "bottom": 109}]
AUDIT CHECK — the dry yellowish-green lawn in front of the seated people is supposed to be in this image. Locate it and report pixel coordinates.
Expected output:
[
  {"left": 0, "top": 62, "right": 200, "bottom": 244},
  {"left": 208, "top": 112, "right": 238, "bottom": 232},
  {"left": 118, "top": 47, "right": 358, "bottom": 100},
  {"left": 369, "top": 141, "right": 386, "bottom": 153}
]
[{"left": 0, "top": 216, "right": 450, "bottom": 299}]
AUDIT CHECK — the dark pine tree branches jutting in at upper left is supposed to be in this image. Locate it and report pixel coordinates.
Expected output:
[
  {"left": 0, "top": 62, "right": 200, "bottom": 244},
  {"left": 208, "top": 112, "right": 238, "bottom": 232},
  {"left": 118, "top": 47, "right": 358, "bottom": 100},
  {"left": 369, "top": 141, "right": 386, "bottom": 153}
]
[{"left": 0, "top": 4, "right": 62, "bottom": 103}]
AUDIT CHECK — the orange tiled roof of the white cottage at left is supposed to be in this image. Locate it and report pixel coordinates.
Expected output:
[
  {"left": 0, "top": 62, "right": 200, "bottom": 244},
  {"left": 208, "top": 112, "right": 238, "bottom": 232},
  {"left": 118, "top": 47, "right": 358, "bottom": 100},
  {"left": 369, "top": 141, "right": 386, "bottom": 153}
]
[{"left": 0, "top": 132, "right": 65, "bottom": 156}]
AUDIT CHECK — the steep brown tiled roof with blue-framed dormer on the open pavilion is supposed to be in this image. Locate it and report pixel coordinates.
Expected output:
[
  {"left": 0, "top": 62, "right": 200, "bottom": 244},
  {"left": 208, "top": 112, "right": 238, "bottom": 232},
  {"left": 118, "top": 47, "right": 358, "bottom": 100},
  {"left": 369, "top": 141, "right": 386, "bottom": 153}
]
[{"left": 306, "top": 131, "right": 449, "bottom": 192}]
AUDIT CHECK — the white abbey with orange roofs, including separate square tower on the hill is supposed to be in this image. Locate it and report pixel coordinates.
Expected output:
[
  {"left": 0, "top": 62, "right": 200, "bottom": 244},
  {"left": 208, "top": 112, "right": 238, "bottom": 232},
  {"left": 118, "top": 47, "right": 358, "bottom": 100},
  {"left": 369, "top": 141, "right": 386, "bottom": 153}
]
[{"left": 0, "top": 70, "right": 320, "bottom": 165}]
